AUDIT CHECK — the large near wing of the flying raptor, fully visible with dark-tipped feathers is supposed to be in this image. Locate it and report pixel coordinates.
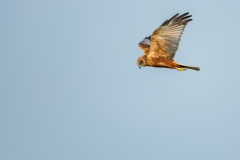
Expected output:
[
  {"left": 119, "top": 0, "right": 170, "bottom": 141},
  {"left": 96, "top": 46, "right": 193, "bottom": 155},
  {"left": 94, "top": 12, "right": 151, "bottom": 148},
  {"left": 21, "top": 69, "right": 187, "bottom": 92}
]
[{"left": 149, "top": 13, "right": 192, "bottom": 59}]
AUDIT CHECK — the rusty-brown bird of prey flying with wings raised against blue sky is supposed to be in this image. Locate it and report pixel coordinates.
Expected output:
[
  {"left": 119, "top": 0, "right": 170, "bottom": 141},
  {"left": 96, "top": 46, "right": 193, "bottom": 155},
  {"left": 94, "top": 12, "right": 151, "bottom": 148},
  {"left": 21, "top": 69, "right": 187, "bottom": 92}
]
[{"left": 137, "top": 13, "right": 200, "bottom": 71}]
